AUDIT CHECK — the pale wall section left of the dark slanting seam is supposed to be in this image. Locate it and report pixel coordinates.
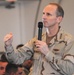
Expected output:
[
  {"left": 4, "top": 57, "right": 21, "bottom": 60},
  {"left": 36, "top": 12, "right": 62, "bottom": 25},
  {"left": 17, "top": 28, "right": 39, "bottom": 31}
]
[{"left": 0, "top": 0, "right": 39, "bottom": 51}]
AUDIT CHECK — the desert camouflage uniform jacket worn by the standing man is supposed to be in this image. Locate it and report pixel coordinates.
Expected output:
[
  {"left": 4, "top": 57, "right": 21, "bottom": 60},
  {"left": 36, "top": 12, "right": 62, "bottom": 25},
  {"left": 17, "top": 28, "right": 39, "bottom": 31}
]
[{"left": 5, "top": 29, "right": 74, "bottom": 75}]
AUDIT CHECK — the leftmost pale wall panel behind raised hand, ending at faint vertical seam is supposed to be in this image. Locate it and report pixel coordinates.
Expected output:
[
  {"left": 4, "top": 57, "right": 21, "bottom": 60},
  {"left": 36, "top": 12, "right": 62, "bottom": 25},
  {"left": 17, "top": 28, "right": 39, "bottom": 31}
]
[{"left": 0, "top": 5, "right": 21, "bottom": 51}]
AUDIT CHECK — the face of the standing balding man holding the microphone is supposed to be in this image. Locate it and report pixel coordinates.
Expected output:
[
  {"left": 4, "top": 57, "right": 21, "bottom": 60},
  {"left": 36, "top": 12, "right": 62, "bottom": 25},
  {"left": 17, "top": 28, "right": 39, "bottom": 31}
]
[{"left": 42, "top": 5, "right": 58, "bottom": 28}]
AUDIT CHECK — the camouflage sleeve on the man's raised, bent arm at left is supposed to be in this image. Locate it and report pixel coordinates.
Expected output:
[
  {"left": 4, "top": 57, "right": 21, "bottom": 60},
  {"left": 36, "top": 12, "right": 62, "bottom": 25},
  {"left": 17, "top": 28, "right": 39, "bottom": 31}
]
[{"left": 5, "top": 38, "right": 35, "bottom": 64}]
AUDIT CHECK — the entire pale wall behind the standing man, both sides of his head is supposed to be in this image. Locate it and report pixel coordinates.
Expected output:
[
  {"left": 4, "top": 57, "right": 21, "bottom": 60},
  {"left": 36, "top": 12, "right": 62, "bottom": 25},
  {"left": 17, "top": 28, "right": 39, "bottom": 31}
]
[{"left": 0, "top": 0, "right": 74, "bottom": 51}]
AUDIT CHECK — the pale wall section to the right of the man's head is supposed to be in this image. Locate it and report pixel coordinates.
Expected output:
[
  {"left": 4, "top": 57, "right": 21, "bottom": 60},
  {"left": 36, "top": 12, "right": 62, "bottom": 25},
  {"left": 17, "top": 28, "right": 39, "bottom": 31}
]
[{"left": 61, "top": 0, "right": 74, "bottom": 36}]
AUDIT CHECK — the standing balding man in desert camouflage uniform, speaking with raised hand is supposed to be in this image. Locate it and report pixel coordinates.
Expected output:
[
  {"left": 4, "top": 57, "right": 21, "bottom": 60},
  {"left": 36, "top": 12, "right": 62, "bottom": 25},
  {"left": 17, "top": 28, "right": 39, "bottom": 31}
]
[{"left": 4, "top": 3, "right": 74, "bottom": 75}]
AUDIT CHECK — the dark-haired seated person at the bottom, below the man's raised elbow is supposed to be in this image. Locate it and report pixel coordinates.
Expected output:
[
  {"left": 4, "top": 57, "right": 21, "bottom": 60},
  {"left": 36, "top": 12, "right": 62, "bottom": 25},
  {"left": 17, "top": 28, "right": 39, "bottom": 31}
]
[{"left": 5, "top": 63, "right": 26, "bottom": 75}]
